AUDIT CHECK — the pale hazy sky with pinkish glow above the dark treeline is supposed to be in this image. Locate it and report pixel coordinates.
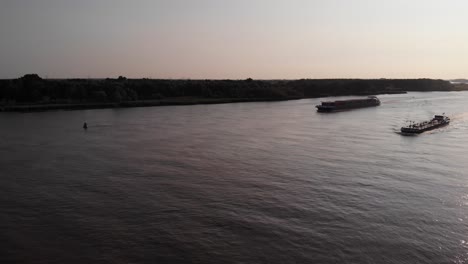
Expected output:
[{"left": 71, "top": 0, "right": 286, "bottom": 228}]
[{"left": 0, "top": 0, "right": 468, "bottom": 79}]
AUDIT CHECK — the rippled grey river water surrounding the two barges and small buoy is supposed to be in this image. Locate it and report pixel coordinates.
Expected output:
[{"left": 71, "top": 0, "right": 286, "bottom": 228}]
[{"left": 0, "top": 92, "right": 468, "bottom": 263}]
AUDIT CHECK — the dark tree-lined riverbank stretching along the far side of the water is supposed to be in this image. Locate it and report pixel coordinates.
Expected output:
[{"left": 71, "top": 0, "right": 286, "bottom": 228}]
[{"left": 0, "top": 74, "right": 468, "bottom": 112}]
